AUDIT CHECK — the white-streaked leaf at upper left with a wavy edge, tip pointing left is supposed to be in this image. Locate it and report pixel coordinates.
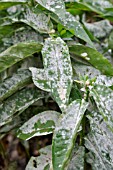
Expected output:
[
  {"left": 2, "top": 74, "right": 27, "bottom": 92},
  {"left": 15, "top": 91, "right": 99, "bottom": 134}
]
[{"left": 9, "top": 6, "right": 53, "bottom": 33}]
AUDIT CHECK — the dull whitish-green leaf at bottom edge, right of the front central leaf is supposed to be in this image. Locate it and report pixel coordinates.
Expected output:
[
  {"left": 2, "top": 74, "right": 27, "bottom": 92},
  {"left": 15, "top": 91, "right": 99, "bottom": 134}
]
[{"left": 68, "top": 146, "right": 85, "bottom": 170}]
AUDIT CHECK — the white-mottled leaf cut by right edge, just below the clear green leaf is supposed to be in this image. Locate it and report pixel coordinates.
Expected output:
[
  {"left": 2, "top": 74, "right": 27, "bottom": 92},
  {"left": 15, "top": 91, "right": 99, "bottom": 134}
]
[{"left": 90, "top": 85, "right": 113, "bottom": 132}]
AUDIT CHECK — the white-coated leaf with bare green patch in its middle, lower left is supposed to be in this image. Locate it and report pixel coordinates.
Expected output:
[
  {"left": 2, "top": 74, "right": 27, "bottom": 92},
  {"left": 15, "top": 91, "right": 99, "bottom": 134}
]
[{"left": 17, "top": 111, "right": 60, "bottom": 140}]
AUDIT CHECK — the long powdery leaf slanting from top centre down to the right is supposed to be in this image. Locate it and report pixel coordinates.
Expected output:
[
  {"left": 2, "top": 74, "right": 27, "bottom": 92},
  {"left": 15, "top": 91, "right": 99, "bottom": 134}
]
[{"left": 36, "top": 0, "right": 94, "bottom": 47}]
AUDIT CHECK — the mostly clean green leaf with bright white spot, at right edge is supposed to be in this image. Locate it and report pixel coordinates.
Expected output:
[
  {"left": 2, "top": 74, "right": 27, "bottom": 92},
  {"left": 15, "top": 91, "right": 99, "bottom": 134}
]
[{"left": 69, "top": 44, "right": 113, "bottom": 76}]
